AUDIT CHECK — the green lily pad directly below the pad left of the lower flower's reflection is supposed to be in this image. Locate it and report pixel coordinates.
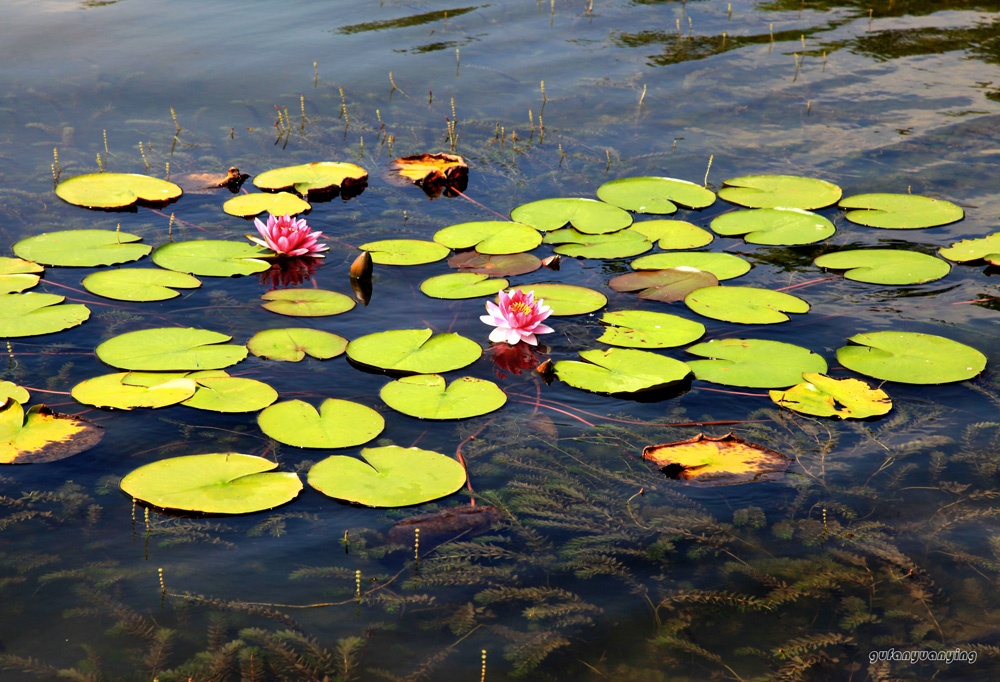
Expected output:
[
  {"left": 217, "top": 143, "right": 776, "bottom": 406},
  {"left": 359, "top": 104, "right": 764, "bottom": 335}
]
[{"left": 379, "top": 374, "right": 507, "bottom": 419}]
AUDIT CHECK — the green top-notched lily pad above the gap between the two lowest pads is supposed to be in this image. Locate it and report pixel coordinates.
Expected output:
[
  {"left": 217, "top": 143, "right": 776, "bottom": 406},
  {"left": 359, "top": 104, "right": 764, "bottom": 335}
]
[{"left": 257, "top": 398, "right": 385, "bottom": 448}]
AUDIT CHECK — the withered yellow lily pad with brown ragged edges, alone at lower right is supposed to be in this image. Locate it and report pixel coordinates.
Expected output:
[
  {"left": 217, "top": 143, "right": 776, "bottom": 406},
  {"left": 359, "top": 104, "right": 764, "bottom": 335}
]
[{"left": 642, "top": 433, "right": 792, "bottom": 486}]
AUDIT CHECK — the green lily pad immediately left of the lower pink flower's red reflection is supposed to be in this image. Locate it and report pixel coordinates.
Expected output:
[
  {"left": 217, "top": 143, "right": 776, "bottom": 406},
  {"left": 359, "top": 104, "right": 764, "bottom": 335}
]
[{"left": 347, "top": 328, "right": 482, "bottom": 374}]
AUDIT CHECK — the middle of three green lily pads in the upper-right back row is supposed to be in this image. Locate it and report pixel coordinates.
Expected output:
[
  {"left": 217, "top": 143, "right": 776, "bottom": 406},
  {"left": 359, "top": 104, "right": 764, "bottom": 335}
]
[{"left": 719, "top": 175, "right": 841, "bottom": 210}]
